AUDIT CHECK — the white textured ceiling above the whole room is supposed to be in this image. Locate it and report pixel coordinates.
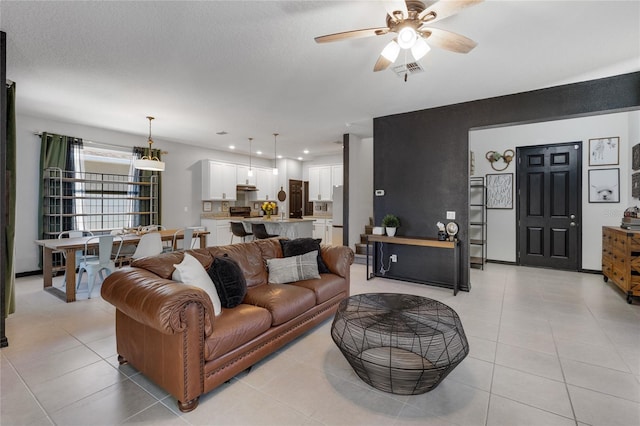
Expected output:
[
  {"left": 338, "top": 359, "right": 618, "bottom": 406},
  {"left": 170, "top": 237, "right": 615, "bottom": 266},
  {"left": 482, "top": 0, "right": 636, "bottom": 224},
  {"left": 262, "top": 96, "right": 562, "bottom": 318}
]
[{"left": 0, "top": 0, "right": 640, "bottom": 159}]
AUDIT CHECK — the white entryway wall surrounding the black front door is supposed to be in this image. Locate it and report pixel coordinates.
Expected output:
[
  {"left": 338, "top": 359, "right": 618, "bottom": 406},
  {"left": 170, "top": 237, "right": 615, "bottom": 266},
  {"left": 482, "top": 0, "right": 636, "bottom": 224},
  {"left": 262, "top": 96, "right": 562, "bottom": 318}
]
[{"left": 469, "top": 111, "right": 640, "bottom": 270}]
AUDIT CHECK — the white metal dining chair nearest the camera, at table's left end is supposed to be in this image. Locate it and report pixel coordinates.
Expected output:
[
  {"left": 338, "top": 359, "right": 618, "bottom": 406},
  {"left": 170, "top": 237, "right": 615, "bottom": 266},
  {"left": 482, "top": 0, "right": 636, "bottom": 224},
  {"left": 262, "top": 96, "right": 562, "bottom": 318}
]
[{"left": 76, "top": 235, "right": 122, "bottom": 299}]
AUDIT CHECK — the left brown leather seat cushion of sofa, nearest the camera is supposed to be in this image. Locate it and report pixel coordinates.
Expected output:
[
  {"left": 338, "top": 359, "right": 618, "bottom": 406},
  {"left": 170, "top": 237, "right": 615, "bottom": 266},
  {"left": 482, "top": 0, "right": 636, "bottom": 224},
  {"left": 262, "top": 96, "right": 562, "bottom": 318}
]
[{"left": 204, "top": 304, "right": 271, "bottom": 361}]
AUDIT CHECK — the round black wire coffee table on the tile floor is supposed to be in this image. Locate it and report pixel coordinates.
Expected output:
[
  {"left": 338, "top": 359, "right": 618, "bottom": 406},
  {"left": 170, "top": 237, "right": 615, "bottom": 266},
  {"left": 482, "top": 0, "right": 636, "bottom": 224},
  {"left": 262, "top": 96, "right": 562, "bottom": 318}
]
[{"left": 331, "top": 293, "right": 469, "bottom": 395}]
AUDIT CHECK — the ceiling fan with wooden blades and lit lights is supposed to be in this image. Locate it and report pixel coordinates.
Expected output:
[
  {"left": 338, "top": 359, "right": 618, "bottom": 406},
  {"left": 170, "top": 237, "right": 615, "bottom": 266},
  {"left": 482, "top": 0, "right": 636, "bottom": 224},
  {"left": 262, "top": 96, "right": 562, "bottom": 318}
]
[{"left": 315, "top": 0, "right": 483, "bottom": 72}]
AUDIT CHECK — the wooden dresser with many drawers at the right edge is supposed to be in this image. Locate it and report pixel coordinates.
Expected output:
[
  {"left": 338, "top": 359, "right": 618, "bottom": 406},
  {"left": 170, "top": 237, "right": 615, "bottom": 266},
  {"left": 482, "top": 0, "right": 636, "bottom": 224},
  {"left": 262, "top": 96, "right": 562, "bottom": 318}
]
[{"left": 602, "top": 226, "right": 640, "bottom": 303}]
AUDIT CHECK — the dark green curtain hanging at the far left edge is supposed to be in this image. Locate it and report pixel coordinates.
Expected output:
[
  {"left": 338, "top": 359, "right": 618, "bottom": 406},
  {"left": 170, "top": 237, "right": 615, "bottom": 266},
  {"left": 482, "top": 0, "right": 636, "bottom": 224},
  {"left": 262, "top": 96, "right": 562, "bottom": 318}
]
[{"left": 3, "top": 83, "right": 16, "bottom": 318}]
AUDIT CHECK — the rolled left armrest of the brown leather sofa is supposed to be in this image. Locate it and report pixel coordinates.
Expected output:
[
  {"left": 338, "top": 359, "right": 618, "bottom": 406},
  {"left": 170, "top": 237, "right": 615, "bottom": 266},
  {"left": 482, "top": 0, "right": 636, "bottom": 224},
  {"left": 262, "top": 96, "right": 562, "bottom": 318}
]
[{"left": 101, "top": 267, "right": 215, "bottom": 337}]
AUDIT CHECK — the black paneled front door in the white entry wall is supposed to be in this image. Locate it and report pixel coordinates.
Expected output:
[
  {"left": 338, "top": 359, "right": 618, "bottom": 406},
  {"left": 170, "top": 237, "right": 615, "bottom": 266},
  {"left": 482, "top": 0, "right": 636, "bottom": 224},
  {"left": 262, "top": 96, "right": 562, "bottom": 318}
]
[{"left": 516, "top": 142, "right": 582, "bottom": 271}]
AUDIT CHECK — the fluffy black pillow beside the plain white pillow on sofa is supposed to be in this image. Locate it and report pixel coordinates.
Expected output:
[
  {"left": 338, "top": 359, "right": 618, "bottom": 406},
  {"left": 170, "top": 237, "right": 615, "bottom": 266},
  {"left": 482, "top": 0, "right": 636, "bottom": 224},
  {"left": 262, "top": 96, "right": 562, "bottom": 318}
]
[{"left": 207, "top": 254, "right": 247, "bottom": 308}]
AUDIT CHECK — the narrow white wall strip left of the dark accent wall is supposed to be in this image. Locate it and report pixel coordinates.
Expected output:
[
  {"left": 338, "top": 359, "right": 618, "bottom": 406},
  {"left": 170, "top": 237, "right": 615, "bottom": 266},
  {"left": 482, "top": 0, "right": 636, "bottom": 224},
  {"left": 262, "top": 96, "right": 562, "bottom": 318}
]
[{"left": 348, "top": 134, "right": 373, "bottom": 251}]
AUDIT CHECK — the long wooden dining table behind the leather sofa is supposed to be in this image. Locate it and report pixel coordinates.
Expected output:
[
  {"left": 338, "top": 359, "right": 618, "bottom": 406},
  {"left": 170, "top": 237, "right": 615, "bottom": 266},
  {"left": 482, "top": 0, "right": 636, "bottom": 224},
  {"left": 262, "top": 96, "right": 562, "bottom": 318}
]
[{"left": 35, "top": 229, "right": 209, "bottom": 302}]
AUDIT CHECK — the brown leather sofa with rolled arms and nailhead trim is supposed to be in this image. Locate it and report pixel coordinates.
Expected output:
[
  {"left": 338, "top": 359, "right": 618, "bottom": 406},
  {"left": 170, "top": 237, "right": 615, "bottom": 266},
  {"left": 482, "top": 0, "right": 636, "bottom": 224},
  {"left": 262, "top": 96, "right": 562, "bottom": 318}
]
[{"left": 101, "top": 239, "right": 354, "bottom": 412}]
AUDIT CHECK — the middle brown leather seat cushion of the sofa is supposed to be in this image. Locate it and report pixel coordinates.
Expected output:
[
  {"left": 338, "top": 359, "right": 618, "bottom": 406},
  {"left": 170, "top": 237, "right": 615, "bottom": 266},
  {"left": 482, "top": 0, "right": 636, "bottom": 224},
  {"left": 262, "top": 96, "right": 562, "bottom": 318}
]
[{"left": 244, "top": 284, "right": 316, "bottom": 326}]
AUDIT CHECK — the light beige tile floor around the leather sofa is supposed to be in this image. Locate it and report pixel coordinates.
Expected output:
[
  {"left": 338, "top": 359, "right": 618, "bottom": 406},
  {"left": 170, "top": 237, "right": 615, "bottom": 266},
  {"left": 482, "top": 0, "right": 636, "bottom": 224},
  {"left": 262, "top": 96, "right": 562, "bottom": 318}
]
[{"left": 0, "top": 264, "right": 640, "bottom": 426}]
